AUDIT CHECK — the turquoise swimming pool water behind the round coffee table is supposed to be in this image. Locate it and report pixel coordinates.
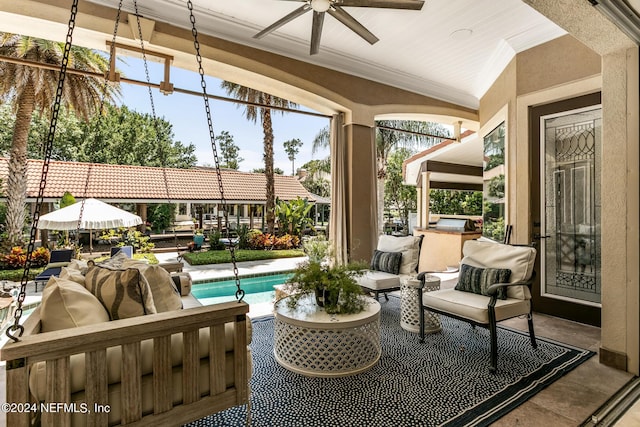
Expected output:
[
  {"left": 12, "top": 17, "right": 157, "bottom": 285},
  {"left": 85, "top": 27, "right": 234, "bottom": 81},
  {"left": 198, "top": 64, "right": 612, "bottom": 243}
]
[{"left": 191, "top": 273, "right": 292, "bottom": 305}]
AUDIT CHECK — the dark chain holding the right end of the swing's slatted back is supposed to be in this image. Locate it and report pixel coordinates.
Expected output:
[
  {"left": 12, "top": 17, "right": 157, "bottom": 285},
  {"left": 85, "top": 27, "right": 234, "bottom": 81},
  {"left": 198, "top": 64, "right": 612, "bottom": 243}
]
[{"left": 187, "top": 0, "right": 245, "bottom": 302}]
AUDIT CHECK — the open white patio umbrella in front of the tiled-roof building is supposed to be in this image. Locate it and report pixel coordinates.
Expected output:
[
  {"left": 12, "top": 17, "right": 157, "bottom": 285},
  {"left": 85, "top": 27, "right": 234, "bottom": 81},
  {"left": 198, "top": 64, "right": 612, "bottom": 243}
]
[{"left": 38, "top": 199, "right": 142, "bottom": 250}]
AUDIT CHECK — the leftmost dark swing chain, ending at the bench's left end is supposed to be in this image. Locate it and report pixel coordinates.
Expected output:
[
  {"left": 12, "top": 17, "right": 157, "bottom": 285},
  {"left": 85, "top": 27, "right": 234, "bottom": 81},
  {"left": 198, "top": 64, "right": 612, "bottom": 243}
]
[{"left": 6, "top": 0, "right": 78, "bottom": 342}]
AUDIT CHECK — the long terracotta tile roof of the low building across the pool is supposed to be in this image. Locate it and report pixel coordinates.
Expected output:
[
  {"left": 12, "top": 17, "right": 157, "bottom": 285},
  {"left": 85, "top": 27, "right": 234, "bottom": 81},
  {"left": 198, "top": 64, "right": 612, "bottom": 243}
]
[{"left": 0, "top": 158, "right": 316, "bottom": 203}]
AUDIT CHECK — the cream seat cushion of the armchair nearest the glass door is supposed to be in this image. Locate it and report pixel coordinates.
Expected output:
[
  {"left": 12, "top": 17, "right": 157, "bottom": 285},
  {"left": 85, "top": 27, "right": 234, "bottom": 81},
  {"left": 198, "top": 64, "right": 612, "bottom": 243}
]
[{"left": 422, "top": 289, "right": 531, "bottom": 325}]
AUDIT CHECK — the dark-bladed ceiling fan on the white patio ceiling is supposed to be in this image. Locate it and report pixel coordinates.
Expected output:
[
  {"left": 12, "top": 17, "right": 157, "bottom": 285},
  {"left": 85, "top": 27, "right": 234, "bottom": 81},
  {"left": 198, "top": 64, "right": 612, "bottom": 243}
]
[{"left": 253, "top": 0, "right": 424, "bottom": 55}]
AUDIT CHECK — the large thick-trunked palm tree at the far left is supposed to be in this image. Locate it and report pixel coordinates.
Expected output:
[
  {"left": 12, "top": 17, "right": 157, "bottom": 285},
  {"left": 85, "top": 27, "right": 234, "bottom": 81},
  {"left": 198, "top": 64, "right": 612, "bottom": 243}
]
[{"left": 0, "top": 33, "right": 119, "bottom": 247}]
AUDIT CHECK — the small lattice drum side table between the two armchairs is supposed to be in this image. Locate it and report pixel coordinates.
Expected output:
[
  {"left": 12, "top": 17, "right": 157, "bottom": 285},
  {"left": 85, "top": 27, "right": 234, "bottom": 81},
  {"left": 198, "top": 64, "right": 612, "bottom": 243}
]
[{"left": 400, "top": 274, "right": 442, "bottom": 334}]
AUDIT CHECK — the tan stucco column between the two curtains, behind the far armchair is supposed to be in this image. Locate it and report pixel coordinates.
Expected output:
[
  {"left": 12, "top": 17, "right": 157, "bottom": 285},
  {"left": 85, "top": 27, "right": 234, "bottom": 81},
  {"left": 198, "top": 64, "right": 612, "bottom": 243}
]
[{"left": 344, "top": 123, "right": 377, "bottom": 261}]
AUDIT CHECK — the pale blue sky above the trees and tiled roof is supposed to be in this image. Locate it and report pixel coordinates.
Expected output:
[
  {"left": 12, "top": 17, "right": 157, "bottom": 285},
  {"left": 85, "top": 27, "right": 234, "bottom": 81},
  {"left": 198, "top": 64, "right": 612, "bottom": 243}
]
[{"left": 117, "top": 58, "right": 329, "bottom": 175}]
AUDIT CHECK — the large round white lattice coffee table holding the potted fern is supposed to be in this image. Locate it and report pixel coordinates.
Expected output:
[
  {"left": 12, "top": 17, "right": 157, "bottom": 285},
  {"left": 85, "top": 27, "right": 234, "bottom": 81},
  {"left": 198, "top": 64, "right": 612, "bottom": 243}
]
[{"left": 273, "top": 295, "right": 381, "bottom": 377}]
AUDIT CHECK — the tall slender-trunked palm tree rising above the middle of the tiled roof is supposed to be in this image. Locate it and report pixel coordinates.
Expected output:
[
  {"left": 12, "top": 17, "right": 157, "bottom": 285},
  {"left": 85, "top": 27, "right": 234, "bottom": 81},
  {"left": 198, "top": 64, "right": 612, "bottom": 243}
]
[{"left": 221, "top": 81, "right": 298, "bottom": 233}]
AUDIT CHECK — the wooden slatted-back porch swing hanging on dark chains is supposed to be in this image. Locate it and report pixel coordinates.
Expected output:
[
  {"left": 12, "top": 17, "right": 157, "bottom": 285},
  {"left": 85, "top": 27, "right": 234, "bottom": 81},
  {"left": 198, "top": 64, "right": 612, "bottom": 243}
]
[{"left": 0, "top": 0, "right": 251, "bottom": 426}]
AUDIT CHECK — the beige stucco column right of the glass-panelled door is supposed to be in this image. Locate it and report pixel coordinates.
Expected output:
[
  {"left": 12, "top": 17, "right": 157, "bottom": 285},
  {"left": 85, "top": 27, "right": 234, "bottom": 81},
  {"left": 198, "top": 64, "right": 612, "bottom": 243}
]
[{"left": 600, "top": 47, "right": 640, "bottom": 375}]
